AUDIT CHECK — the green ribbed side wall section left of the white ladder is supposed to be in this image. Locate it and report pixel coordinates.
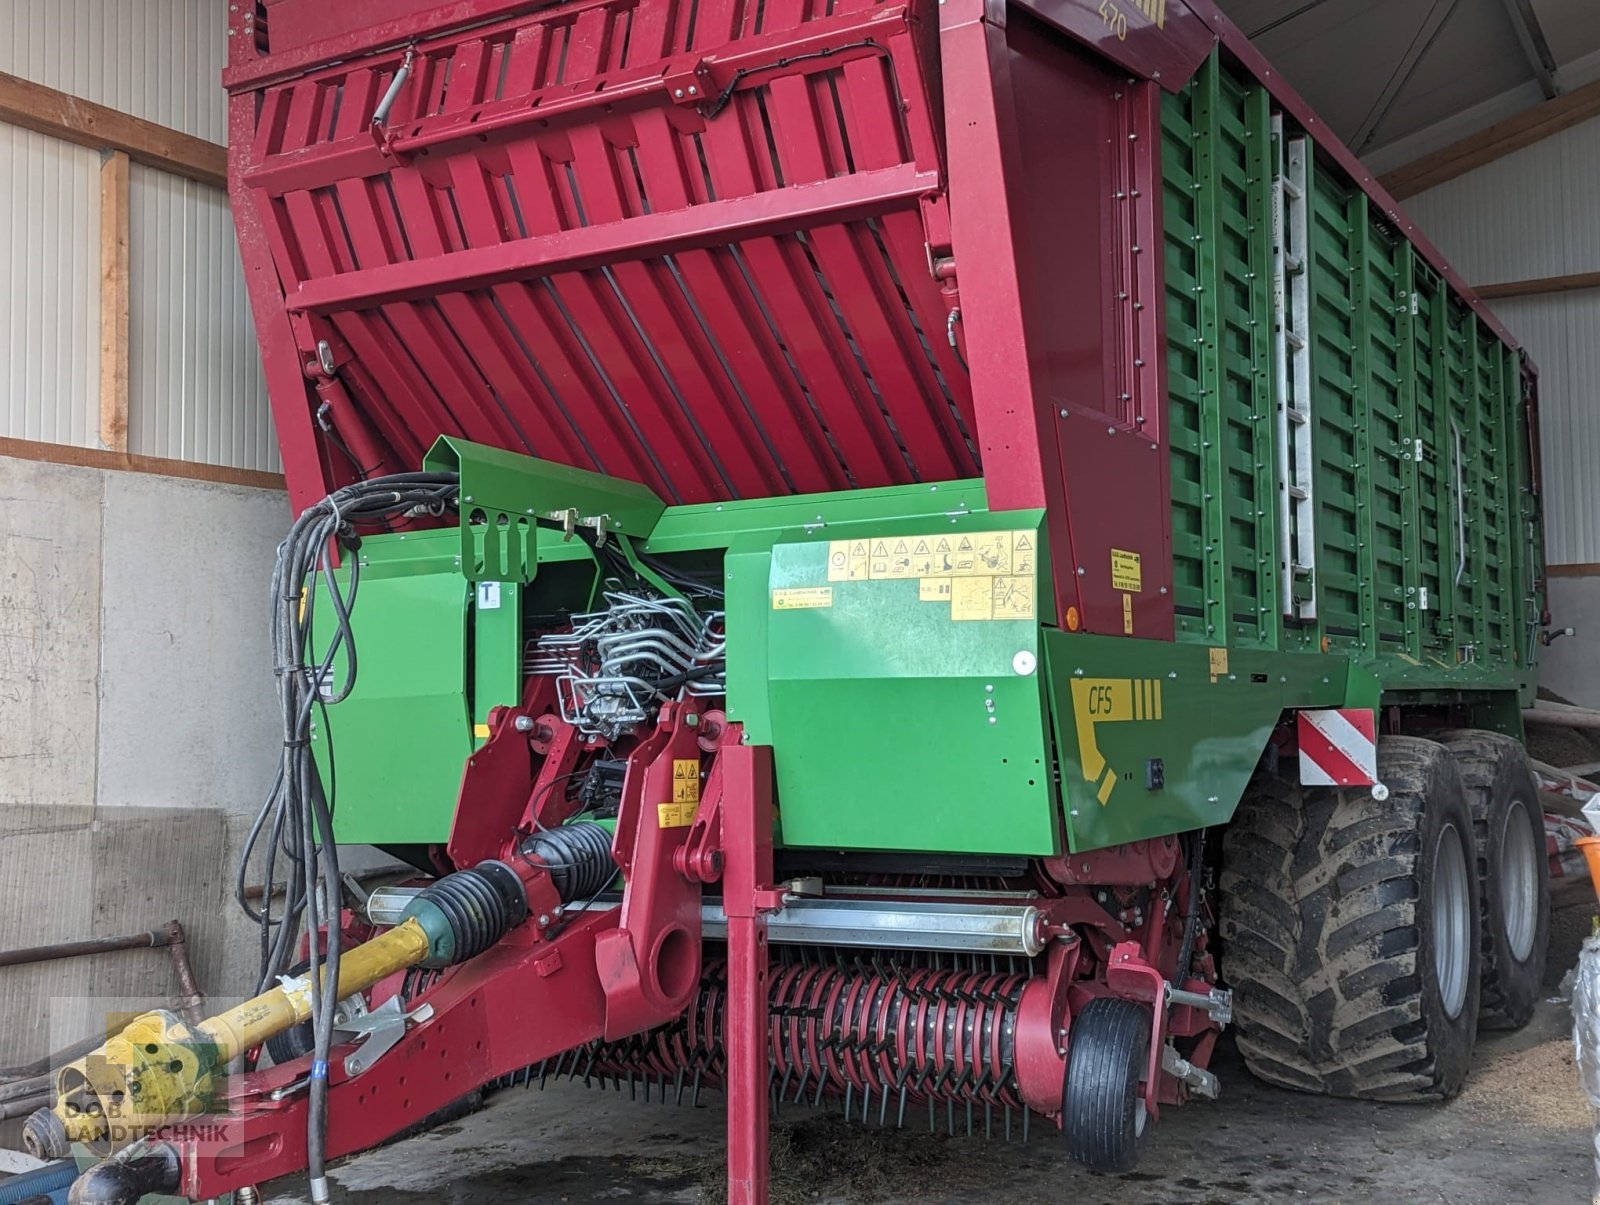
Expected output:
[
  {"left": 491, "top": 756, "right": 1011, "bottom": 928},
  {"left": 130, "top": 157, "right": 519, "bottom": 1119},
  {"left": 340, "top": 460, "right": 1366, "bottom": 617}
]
[{"left": 1162, "top": 49, "right": 1278, "bottom": 647}]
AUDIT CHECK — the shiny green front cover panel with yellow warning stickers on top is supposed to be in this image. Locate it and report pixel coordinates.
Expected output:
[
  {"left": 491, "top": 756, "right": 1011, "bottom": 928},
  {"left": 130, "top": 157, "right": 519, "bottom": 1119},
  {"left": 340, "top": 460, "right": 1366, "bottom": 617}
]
[{"left": 755, "top": 514, "right": 1058, "bottom": 855}]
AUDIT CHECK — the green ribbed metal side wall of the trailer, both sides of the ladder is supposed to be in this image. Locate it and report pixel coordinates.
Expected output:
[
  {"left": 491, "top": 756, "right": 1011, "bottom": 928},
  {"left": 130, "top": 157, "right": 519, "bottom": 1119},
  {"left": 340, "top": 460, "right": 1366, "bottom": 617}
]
[{"left": 1163, "top": 54, "right": 1542, "bottom": 698}]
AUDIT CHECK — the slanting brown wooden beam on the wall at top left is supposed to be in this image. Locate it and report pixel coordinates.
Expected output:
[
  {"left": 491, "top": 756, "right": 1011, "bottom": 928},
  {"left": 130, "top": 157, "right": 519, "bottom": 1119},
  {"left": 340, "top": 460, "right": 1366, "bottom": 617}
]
[{"left": 0, "top": 72, "right": 227, "bottom": 189}]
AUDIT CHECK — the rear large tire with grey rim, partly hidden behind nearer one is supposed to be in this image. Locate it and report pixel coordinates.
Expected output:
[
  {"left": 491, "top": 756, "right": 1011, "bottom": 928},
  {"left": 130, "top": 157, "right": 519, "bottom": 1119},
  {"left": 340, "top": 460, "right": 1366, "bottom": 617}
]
[{"left": 1442, "top": 731, "right": 1550, "bottom": 1029}]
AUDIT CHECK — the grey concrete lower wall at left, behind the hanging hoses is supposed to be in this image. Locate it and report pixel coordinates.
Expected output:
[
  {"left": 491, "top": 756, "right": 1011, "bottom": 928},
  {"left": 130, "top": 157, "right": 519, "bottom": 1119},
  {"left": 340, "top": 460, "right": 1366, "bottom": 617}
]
[{"left": 0, "top": 458, "right": 290, "bottom": 1064}]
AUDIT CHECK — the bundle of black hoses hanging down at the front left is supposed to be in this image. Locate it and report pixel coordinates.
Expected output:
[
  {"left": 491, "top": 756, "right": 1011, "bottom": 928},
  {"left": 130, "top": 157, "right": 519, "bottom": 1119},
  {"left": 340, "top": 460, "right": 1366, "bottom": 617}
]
[{"left": 235, "top": 472, "right": 459, "bottom": 1203}]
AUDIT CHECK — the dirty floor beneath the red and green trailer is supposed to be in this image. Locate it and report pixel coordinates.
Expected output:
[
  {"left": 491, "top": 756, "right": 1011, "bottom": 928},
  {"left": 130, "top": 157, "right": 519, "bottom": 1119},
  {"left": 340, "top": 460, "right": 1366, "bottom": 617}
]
[{"left": 262, "top": 887, "right": 1595, "bottom": 1205}]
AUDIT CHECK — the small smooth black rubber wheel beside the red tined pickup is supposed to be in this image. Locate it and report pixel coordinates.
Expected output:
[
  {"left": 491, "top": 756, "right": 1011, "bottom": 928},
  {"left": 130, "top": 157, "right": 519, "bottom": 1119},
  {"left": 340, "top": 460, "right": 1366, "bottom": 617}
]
[{"left": 1061, "top": 997, "right": 1150, "bottom": 1171}]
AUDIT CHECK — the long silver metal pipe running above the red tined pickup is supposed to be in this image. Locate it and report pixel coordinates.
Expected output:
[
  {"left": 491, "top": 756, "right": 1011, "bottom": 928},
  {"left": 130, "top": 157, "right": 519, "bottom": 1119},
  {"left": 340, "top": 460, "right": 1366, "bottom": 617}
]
[{"left": 366, "top": 887, "right": 1045, "bottom": 959}]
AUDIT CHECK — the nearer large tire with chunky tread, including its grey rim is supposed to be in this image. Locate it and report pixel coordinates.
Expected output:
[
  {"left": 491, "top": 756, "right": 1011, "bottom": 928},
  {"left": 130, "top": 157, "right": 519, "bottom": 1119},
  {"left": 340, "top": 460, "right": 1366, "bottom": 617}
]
[{"left": 1221, "top": 736, "right": 1480, "bottom": 1101}]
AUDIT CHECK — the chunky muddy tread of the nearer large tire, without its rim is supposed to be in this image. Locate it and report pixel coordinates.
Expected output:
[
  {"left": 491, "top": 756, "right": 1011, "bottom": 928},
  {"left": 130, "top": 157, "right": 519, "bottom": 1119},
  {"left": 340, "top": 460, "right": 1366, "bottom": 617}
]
[{"left": 1221, "top": 738, "right": 1459, "bottom": 1101}]
